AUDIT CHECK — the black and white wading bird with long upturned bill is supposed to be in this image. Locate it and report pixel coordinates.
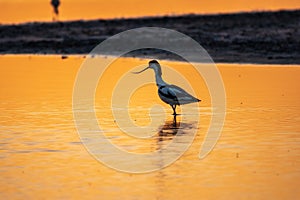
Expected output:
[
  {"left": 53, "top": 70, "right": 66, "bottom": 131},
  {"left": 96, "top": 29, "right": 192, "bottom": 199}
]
[{"left": 133, "top": 60, "right": 201, "bottom": 116}]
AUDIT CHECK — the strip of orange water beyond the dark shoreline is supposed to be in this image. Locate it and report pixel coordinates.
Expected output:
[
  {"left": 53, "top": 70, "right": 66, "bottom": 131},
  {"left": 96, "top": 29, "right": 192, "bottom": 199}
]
[{"left": 0, "top": 0, "right": 300, "bottom": 23}]
